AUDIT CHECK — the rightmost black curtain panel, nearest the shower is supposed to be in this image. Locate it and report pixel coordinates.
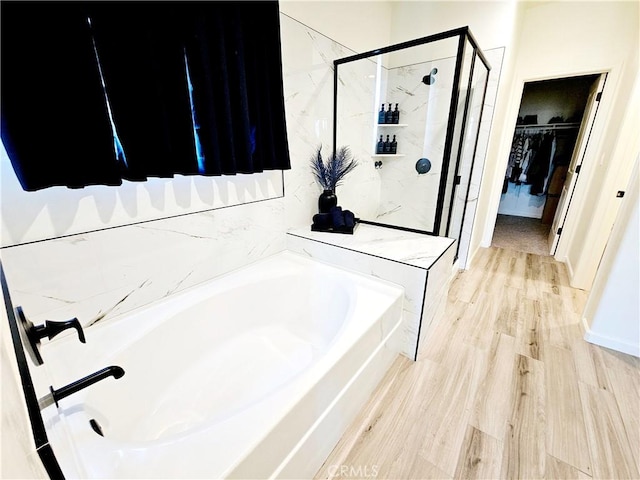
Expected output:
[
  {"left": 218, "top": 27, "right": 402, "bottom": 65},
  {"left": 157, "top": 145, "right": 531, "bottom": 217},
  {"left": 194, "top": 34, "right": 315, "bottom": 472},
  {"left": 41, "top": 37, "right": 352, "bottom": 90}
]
[{"left": 187, "top": 2, "right": 289, "bottom": 174}]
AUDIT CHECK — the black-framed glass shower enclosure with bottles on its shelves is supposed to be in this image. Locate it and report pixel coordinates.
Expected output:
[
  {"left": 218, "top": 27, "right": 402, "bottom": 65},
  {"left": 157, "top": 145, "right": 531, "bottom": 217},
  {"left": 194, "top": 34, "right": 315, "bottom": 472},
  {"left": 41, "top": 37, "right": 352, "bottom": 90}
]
[{"left": 333, "top": 27, "right": 491, "bottom": 257}]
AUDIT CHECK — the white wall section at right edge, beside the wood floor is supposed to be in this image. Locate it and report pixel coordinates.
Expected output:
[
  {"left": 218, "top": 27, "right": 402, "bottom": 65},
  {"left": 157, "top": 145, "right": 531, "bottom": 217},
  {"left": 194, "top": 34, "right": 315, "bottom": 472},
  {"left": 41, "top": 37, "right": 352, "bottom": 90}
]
[{"left": 583, "top": 160, "right": 640, "bottom": 357}]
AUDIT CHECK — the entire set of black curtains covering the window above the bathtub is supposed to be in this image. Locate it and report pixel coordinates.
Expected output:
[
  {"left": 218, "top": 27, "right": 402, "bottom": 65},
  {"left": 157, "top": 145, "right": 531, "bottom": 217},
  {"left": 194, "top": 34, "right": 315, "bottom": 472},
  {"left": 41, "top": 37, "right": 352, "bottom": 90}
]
[{"left": 2, "top": 2, "right": 290, "bottom": 190}]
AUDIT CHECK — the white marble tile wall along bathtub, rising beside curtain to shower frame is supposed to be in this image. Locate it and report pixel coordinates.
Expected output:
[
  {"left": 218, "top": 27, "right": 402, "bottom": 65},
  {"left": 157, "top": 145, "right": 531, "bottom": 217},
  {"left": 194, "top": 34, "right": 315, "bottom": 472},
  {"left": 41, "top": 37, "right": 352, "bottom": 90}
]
[{"left": 1, "top": 15, "right": 354, "bottom": 326}]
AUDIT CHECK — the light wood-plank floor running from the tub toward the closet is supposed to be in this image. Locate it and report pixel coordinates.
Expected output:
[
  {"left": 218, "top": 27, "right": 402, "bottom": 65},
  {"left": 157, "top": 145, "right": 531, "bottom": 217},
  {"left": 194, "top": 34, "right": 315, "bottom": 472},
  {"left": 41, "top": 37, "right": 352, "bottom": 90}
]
[{"left": 316, "top": 247, "right": 640, "bottom": 479}]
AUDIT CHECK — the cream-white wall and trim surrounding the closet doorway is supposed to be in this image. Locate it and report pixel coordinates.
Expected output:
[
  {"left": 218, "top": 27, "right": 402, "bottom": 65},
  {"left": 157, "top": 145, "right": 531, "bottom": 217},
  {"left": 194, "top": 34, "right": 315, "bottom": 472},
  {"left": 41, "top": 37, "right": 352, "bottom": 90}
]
[{"left": 472, "top": 2, "right": 638, "bottom": 288}]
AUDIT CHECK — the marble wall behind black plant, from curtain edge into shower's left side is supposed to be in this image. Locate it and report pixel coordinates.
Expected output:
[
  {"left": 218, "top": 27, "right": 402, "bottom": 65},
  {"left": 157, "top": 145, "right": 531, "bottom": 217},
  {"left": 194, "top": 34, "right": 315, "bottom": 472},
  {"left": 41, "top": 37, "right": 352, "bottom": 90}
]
[{"left": 281, "top": 15, "right": 379, "bottom": 227}]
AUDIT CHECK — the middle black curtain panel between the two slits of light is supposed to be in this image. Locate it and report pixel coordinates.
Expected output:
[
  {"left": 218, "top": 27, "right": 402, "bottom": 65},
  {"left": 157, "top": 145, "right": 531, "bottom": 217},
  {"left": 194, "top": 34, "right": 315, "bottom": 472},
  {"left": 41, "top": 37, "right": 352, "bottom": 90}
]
[{"left": 90, "top": 2, "right": 198, "bottom": 180}]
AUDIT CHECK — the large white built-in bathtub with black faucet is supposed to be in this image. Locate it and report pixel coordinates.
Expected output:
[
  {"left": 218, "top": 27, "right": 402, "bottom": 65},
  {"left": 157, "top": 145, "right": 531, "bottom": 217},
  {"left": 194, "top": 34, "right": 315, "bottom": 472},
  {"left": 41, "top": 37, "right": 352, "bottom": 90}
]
[{"left": 37, "top": 252, "right": 403, "bottom": 478}]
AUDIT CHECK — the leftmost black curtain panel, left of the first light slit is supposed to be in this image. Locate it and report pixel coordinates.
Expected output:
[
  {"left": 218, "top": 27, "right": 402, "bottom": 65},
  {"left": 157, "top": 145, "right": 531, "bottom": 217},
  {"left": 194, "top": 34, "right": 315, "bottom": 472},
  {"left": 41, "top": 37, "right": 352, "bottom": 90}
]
[{"left": 0, "top": 1, "right": 121, "bottom": 190}]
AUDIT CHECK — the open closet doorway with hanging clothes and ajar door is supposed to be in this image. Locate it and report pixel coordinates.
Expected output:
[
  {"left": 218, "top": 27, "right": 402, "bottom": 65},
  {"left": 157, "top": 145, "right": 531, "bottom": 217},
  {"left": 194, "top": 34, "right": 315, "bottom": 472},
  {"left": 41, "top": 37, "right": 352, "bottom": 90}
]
[{"left": 492, "top": 74, "right": 606, "bottom": 255}]
